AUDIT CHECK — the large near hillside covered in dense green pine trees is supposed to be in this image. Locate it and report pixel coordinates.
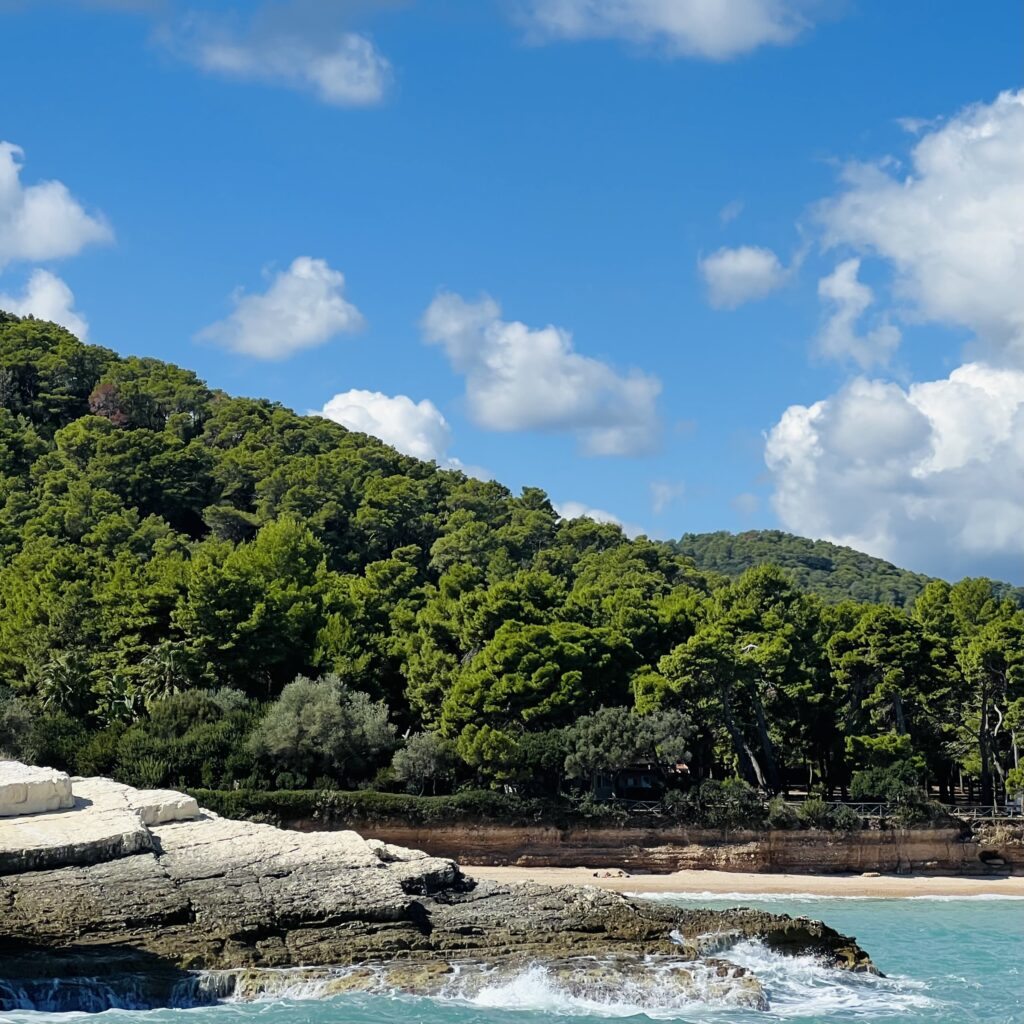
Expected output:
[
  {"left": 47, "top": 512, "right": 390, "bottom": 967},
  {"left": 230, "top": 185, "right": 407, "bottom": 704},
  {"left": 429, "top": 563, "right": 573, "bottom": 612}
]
[{"left": 0, "top": 313, "right": 1024, "bottom": 813}]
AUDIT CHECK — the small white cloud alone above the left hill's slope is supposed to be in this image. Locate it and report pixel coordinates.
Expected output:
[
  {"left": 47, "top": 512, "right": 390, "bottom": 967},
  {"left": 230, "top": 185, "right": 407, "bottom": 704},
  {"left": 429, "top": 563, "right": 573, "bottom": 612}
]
[{"left": 197, "top": 256, "right": 365, "bottom": 359}]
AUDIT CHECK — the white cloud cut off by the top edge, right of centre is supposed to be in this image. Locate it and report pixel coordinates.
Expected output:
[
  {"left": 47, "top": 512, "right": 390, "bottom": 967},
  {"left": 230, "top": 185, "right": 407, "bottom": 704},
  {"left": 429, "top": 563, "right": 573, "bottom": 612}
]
[{"left": 523, "top": 0, "right": 809, "bottom": 60}]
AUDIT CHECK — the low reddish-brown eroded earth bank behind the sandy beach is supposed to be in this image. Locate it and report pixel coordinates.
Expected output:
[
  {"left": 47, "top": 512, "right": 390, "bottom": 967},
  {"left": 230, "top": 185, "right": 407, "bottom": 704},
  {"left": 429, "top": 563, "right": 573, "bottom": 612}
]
[{"left": 327, "top": 821, "right": 1024, "bottom": 874}]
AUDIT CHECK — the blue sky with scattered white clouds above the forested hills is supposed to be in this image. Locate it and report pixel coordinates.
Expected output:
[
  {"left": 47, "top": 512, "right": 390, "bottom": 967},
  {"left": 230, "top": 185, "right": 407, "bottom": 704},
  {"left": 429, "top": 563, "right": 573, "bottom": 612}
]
[{"left": 0, "top": 0, "right": 1024, "bottom": 582}]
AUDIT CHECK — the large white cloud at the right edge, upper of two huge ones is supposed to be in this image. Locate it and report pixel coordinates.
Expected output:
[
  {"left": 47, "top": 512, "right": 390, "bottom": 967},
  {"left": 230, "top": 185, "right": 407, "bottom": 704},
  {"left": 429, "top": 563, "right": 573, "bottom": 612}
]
[{"left": 817, "top": 91, "right": 1024, "bottom": 365}]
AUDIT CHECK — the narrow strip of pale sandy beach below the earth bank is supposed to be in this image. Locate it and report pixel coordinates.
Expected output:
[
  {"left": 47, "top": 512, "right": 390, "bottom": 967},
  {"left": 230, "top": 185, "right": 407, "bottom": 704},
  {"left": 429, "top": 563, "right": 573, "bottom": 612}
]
[{"left": 463, "top": 865, "right": 1024, "bottom": 898}]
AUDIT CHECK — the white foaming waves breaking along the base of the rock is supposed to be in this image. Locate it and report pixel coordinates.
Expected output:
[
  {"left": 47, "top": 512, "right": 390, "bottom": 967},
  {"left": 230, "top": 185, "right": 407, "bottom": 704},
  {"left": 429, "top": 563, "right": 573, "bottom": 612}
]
[{"left": 0, "top": 941, "right": 933, "bottom": 1024}]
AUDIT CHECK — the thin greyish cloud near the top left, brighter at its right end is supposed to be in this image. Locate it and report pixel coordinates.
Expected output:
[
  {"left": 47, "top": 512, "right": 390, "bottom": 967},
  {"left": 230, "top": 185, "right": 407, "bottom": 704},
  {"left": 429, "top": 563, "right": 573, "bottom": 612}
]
[{"left": 165, "top": 5, "right": 391, "bottom": 106}]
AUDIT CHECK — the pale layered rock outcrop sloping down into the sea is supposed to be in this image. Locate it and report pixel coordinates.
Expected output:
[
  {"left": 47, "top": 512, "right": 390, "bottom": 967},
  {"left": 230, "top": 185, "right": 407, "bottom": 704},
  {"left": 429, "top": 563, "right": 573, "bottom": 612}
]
[{"left": 0, "top": 765, "right": 876, "bottom": 1010}]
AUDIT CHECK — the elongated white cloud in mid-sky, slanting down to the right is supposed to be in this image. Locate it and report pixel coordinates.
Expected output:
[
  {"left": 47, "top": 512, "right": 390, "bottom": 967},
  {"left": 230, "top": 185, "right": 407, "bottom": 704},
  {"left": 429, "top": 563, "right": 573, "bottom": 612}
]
[{"left": 422, "top": 294, "right": 662, "bottom": 455}]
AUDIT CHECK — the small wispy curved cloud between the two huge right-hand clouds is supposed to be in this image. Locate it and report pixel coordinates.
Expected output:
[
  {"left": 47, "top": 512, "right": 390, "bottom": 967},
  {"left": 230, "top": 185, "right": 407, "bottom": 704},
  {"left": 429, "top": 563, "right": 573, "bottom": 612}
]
[{"left": 817, "top": 259, "right": 901, "bottom": 370}]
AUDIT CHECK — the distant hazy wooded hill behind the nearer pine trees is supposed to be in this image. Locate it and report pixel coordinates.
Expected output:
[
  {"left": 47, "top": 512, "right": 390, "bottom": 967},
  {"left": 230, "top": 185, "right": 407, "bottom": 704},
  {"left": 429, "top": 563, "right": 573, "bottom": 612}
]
[{"left": 677, "top": 529, "right": 1024, "bottom": 607}]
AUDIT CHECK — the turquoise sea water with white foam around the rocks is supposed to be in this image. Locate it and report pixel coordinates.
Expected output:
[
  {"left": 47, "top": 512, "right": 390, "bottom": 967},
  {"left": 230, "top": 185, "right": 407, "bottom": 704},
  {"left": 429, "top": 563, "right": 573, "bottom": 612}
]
[{"left": 0, "top": 894, "right": 1024, "bottom": 1024}]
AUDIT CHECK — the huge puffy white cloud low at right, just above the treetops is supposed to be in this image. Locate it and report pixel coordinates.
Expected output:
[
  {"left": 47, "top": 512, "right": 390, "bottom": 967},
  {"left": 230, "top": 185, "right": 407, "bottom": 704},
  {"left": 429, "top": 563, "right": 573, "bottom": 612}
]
[{"left": 766, "top": 362, "right": 1024, "bottom": 578}]
